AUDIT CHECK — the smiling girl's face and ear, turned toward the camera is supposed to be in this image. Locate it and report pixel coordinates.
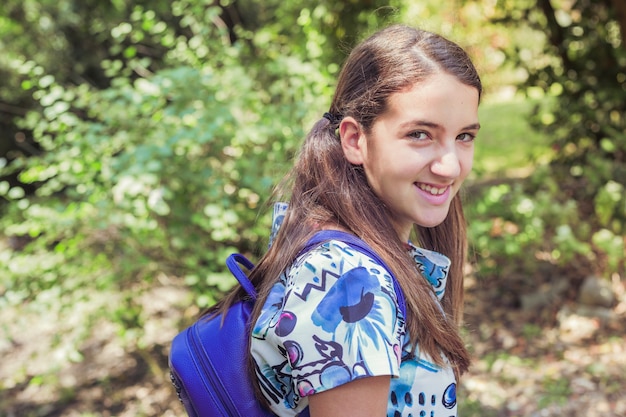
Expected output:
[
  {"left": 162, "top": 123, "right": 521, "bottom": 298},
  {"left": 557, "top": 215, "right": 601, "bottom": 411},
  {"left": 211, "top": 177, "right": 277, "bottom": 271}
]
[{"left": 340, "top": 73, "right": 480, "bottom": 241}]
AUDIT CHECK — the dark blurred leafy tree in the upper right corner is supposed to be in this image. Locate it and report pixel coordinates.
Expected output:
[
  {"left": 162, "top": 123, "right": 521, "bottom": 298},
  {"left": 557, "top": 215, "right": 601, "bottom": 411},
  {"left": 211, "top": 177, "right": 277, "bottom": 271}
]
[{"left": 495, "top": 0, "right": 626, "bottom": 268}]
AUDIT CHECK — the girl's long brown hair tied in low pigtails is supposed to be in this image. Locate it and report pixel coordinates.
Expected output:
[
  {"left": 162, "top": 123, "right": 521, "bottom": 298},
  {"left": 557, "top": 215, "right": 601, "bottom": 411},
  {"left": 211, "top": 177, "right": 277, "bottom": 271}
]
[{"left": 216, "top": 25, "right": 482, "bottom": 380}]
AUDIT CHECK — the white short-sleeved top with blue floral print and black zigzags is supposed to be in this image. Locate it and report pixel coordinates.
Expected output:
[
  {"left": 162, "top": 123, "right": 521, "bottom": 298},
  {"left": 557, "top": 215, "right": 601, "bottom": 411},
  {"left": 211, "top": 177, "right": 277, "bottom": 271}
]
[{"left": 251, "top": 240, "right": 457, "bottom": 417}]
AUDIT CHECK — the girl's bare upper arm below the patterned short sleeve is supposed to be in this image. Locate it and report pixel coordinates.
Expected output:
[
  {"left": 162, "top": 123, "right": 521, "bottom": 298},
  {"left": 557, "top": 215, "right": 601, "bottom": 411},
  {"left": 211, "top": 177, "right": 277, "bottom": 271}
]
[{"left": 309, "top": 375, "right": 391, "bottom": 417}]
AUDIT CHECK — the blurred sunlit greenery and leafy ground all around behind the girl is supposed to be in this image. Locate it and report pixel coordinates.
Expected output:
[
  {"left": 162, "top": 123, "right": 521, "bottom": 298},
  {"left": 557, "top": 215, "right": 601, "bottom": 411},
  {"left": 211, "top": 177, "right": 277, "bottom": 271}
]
[{"left": 0, "top": 0, "right": 626, "bottom": 417}]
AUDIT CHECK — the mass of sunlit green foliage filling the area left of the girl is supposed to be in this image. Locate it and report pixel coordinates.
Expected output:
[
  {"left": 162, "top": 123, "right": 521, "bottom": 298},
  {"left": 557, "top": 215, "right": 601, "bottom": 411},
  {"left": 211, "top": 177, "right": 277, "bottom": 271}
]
[{"left": 0, "top": 0, "right": 400, "bottom": 394}]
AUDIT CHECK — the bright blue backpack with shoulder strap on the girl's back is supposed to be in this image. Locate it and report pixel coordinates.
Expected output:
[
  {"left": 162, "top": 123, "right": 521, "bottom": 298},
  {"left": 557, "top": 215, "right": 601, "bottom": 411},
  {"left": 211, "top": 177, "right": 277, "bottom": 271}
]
[{"left": 169, "top": 230, "right": 406, "bottom": 417}]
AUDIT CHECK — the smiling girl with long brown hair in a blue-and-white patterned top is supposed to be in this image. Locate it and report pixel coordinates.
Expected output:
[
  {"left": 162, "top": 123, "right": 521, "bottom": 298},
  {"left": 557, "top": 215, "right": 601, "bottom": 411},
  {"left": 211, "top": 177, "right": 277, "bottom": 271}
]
[{"left": 227, "top": 25, "right": 482, "bottom": 417}]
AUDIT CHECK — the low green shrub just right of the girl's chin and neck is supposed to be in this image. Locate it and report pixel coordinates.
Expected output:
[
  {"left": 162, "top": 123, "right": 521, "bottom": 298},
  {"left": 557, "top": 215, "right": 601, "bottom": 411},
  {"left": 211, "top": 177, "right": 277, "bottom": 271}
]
[{"left": 467, "top": 162, "right": 625, "bottom": 275}]
